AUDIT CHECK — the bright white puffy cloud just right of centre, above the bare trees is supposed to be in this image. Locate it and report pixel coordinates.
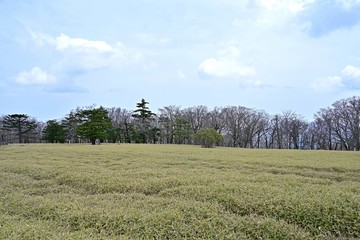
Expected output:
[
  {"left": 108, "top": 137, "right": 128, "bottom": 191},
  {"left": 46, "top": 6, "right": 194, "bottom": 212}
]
[{"left": 198, "top": 45, "right": 255, "bottom": 77}]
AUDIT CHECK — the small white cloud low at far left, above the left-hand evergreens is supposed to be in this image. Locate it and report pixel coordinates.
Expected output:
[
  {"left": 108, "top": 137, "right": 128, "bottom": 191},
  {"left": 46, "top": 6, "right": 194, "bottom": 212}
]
[{"left": 16, "top": 67, "right": 57, "bottom": 85}]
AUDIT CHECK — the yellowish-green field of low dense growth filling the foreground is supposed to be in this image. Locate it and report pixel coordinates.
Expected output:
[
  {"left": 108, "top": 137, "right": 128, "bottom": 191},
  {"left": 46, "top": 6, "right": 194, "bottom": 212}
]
[{"left": 0, "top": 144, "right": 360, "bottom": 239}]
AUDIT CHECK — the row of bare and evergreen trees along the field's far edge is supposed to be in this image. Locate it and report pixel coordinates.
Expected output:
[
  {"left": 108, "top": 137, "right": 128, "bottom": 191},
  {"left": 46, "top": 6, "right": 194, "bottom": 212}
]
[{"left": 0, "top": 97, "right": 360, "bottom": 151}]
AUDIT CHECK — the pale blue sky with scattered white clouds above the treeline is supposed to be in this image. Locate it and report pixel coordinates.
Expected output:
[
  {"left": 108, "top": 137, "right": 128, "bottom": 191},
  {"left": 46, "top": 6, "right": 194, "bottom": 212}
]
[{"left": 0, "top": 0, "right": 360, "bottom": 121}]
